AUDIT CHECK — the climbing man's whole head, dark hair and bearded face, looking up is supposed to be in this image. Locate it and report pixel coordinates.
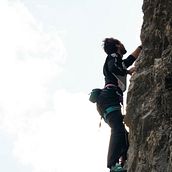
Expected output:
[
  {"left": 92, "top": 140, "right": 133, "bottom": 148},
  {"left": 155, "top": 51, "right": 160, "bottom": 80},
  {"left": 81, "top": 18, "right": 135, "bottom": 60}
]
[{"left": 103, "top": 38, "right": 127, "bottom": 56}]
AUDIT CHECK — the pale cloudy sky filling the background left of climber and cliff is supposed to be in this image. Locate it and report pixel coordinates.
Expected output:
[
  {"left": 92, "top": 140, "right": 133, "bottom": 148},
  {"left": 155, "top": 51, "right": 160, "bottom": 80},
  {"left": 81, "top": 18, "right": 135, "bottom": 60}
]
[{"left": 0, "top": 0, "right": 143, "bottom": 172}]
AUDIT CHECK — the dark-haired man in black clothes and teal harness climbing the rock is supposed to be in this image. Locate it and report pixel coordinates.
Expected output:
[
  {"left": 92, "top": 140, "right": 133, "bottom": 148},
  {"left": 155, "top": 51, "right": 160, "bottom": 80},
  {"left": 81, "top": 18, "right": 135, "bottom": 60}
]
[{"left": 96, "top": 38, "right": 142, "bottom": 172}]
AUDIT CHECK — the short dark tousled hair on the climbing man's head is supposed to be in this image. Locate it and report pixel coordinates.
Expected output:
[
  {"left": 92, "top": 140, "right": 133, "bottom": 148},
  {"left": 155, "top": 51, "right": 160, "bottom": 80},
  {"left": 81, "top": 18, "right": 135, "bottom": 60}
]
[{"left": 103, "top": 38, "right": 120, "bottom": 55}]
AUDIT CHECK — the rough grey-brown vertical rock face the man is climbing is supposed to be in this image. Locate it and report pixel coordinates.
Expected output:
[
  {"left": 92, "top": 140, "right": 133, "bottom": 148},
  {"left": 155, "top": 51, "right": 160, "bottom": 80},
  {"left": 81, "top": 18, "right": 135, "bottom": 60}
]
[{"left": 125, "top": 0, "right": 172, "bottom": 172}]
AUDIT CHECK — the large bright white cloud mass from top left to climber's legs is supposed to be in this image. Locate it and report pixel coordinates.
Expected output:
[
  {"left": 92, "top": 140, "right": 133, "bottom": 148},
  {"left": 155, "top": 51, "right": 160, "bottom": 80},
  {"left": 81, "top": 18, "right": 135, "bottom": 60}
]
[{"left": 0, "top": 0, "right": 108, "bottom": 172}]
